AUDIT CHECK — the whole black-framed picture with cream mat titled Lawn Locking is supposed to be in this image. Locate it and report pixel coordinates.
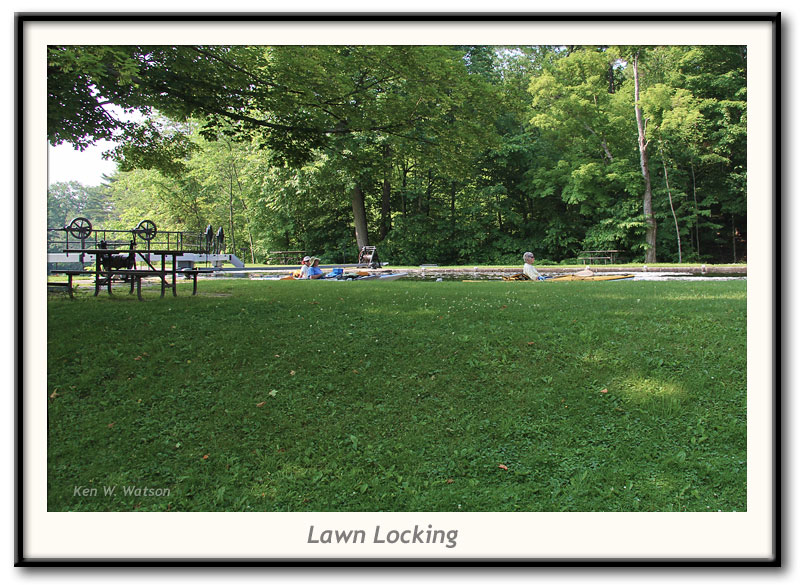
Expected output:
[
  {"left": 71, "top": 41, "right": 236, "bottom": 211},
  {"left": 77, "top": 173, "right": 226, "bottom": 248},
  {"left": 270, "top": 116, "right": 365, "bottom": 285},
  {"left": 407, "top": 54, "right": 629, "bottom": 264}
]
[{"left": 16, "top": 13, "right": 781, "bottom": 566}]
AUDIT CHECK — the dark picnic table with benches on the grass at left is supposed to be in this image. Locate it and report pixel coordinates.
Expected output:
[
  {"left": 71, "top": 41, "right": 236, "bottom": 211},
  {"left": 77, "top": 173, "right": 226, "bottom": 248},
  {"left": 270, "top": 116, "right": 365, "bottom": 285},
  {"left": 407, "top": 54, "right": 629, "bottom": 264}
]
[{"left": 53, "top": 248, "right": 201, "bottom": 300}]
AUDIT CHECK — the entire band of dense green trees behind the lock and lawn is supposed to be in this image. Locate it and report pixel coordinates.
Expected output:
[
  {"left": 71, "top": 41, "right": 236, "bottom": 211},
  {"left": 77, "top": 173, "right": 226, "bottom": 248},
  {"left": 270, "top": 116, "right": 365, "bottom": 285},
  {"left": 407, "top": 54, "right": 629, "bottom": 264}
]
[{"left": 48, "top": 45, "right": 747, "bottom": 264}]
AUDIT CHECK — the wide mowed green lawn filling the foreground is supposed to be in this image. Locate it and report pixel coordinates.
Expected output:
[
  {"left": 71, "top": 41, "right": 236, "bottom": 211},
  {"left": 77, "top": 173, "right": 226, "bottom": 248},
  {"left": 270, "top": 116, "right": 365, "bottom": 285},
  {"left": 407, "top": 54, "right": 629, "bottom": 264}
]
[{"left": 47, "top": 279, "right": 747, "bottom": 512}]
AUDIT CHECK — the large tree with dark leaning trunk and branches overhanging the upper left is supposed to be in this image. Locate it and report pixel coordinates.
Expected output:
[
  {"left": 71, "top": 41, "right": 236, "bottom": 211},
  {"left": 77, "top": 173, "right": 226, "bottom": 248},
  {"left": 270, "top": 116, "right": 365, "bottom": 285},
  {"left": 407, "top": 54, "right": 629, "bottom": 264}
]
[{"left": 50, "top": 45, "right": 500, "bottom": 256}]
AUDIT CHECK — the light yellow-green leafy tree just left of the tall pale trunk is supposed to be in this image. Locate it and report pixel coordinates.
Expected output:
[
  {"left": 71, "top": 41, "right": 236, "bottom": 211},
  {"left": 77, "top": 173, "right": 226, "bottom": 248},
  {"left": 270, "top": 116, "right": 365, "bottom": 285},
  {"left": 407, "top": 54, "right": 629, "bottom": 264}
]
[{"left": 526, "top": 47, "right": 644, "bottom": 257}]
